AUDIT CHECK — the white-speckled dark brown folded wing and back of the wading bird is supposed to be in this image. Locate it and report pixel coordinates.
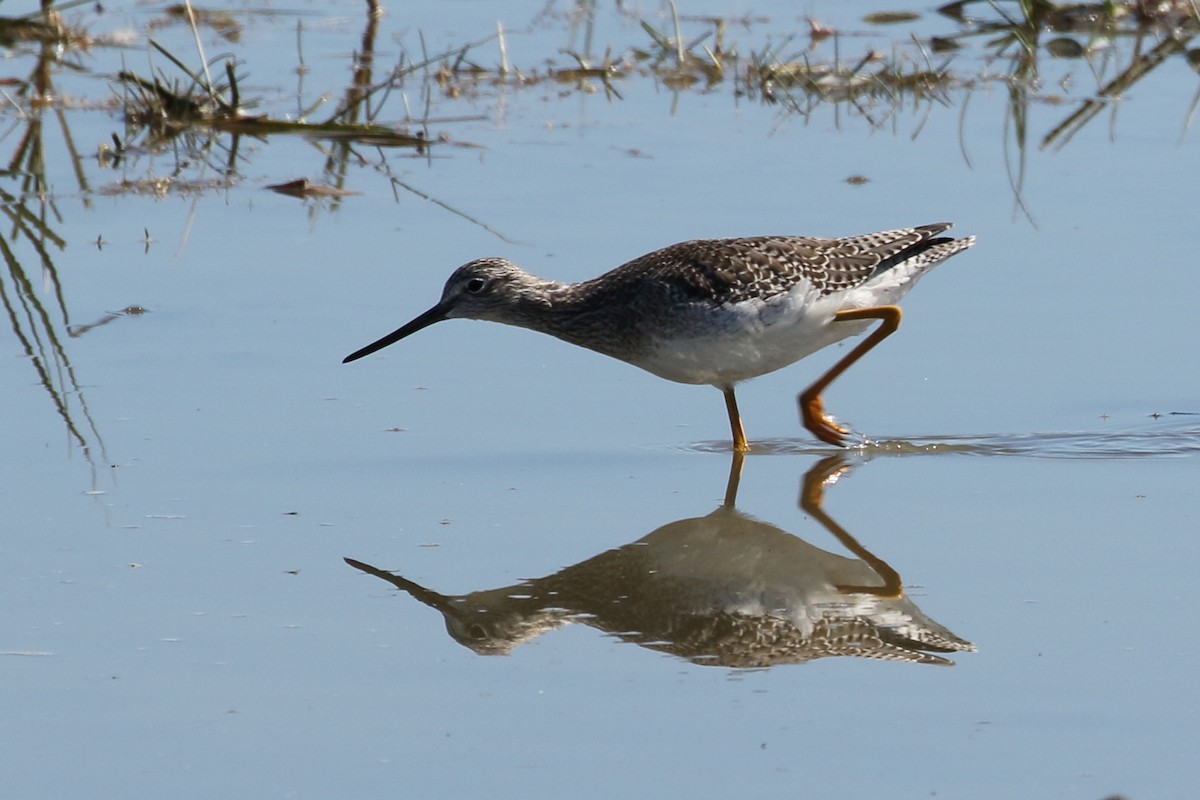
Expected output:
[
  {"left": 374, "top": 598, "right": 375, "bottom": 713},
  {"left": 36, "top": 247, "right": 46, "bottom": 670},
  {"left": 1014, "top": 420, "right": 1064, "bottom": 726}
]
[{"left": 587, "top": 223, "right": 952, "bottom": 303}]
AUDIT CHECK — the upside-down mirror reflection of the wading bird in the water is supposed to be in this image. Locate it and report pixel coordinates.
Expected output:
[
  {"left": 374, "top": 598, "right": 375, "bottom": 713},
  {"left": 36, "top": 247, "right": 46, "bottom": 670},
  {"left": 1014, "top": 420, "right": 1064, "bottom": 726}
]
[{"left": 346, "top": 455, "right": 974, "bottom": 668}]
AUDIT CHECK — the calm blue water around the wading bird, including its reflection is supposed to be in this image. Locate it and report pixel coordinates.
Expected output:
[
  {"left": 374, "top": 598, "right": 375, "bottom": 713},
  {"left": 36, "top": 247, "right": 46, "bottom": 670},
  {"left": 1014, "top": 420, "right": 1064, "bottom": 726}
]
[{"left": 0, "top": 2, "right": 1200, "bottom": 800}]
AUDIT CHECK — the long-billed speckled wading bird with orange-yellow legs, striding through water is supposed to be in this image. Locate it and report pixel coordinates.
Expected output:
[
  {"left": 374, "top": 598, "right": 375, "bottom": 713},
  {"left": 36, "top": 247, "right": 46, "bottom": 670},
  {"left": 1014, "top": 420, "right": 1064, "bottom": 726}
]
[{"left": 343, "top": 222, "right": 974, "bottom": 452}]
